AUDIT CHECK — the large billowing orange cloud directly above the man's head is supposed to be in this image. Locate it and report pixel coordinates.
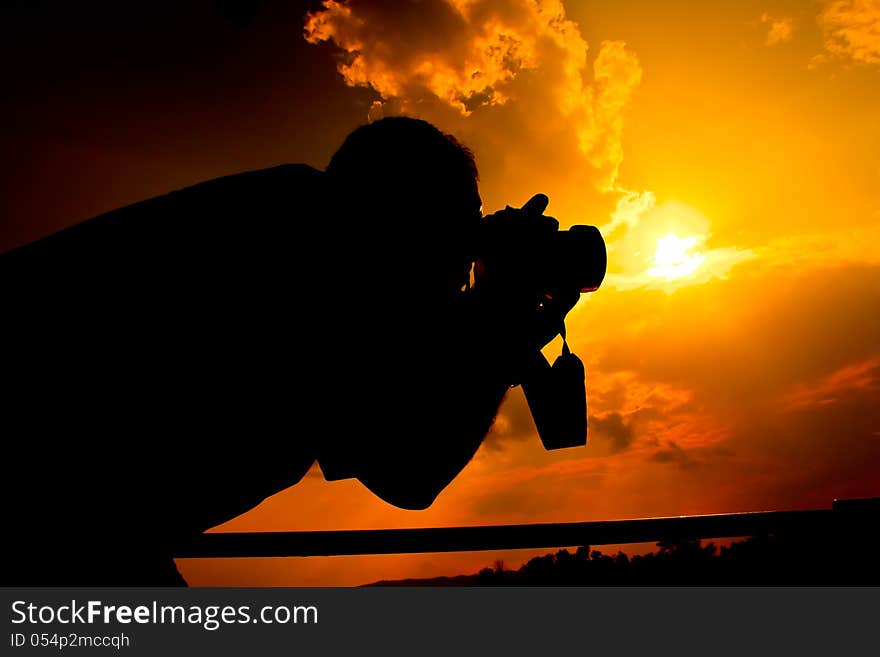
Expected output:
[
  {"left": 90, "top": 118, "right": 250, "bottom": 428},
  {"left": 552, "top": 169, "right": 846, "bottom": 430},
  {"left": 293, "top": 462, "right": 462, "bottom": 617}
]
[{"left": 305, "top": 0, "right": 642, "bottom": 190}]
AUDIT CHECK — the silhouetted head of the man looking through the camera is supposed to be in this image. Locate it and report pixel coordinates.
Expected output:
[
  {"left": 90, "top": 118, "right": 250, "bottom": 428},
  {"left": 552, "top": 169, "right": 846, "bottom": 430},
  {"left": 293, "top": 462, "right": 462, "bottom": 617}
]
[{"left": 327, "top": 117, "right": 481, "bottom": 289}]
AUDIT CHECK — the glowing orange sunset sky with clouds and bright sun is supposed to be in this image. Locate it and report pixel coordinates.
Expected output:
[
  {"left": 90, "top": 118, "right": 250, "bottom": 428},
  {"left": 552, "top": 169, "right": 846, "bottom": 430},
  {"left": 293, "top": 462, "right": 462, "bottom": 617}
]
[{"left": 0, "top": 0, "right": 880, "bottom": 585}]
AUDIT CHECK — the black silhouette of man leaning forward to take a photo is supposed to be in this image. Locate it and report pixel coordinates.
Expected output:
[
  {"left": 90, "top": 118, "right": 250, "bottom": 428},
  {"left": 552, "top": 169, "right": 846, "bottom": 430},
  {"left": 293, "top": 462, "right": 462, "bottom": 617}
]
[{"left": 2, "top": 118, "right": 577, "bottom": 585}]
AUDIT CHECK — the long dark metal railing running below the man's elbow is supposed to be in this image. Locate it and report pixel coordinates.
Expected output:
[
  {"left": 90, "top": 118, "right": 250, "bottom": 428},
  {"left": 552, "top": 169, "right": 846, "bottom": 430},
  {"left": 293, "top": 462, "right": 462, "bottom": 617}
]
[{"left": 175, "top": 497, "right": 880, "bottom": 558}]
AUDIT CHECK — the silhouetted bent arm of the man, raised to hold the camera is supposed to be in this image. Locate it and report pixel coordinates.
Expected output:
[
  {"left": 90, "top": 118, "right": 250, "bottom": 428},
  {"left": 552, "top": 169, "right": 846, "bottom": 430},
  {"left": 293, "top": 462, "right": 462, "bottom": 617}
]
[{"left": 340, "top": 197, "right": 579, "bottom": 509}]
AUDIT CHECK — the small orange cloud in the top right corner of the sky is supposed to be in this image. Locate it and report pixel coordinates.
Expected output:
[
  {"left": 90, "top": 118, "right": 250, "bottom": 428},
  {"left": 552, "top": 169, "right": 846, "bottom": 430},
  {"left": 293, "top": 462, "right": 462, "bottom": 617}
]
[{"left": 819, "top": 0, "right": 880, "bottom": 64}]
